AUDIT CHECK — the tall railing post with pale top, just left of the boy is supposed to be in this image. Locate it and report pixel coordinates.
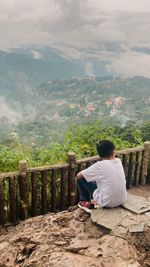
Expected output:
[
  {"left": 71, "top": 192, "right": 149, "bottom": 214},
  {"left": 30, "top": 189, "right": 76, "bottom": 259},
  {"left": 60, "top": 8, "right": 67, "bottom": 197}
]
[{"left": 68, "top": 152, "right": 77, "bottom": 206}]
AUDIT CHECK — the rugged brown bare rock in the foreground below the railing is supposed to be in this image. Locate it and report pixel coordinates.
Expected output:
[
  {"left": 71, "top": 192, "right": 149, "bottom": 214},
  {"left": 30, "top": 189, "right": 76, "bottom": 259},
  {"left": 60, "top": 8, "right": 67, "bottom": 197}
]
[{"left": 0, "top": 203, "right": 150, "bottom": 267}]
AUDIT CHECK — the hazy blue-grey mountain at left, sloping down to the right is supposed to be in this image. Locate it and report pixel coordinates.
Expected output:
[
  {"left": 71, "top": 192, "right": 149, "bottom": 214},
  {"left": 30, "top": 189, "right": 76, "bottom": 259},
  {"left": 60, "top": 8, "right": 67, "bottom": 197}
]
[{"left": 0, "top": 48, "right": 84, "bottom": 91}]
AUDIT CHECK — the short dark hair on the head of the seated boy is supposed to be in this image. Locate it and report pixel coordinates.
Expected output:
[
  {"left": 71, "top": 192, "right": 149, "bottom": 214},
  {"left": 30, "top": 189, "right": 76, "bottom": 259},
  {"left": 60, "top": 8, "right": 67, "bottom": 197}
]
[{"left": 96, "top": 140, "right": 115, "bottom": 158}]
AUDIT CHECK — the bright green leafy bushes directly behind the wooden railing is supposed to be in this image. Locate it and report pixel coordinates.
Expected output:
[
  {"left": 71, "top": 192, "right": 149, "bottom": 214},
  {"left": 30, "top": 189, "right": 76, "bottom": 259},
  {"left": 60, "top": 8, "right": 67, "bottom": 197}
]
[{"left": 0, "top": 121, "right": 150, "bottom": 172}]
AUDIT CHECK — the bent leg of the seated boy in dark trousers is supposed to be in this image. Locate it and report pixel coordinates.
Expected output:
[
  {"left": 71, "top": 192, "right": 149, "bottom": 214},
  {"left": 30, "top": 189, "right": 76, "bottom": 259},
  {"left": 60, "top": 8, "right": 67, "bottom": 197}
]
[{"left": 77, "top": 178, "right": 97, "bottom": 201}]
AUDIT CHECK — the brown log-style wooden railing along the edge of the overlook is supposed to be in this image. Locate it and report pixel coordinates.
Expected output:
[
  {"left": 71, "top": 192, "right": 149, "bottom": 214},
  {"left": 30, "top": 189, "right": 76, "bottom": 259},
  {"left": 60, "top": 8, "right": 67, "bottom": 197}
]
[{"left": 0, "top": 142, "right": 150, "bottom": 225}]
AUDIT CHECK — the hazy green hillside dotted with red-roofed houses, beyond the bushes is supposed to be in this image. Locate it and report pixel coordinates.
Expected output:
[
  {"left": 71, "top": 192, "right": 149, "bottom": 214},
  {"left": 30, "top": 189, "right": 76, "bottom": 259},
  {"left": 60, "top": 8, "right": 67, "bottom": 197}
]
[{"left": 0, "top": 76, "right": 150, "bottom": 147}]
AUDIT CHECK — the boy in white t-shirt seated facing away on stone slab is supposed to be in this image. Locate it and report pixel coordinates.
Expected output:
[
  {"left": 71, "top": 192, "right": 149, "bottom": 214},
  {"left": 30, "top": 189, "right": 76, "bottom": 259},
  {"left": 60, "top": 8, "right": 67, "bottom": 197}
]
[{"left": 77, "top": 140, "right": 127, "bottom": 212}]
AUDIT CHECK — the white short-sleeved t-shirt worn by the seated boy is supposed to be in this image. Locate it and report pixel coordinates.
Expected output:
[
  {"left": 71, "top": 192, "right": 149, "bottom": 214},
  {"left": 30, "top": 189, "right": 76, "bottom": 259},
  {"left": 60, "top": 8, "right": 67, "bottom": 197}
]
[{"left": 82, "top": 158, "right": 127, "bottom": 208}]
